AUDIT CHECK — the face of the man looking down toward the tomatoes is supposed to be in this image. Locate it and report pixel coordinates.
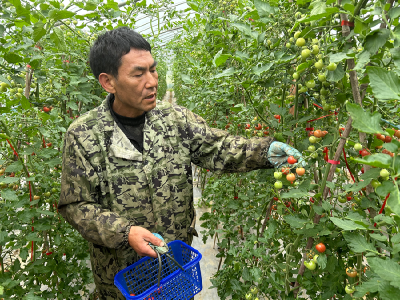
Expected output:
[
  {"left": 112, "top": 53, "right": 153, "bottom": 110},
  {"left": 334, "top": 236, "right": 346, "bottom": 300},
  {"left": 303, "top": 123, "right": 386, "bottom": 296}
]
[{"left": 111, "top": 49, "right": 158, "bottom": 117}]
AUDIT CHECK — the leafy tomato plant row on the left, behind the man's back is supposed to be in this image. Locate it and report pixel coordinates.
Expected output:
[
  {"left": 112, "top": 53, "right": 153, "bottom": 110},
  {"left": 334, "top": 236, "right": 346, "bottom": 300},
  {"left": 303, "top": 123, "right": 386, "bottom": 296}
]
[{"left": 0, "top": 0, "right": 169, "bottom": 299}]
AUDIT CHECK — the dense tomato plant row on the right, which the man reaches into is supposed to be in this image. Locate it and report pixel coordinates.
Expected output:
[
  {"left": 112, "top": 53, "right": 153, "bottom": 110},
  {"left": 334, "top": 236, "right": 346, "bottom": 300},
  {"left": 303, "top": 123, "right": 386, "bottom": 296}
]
[{"left": 173, "top": 0, "right": 400, "bottom": 299}]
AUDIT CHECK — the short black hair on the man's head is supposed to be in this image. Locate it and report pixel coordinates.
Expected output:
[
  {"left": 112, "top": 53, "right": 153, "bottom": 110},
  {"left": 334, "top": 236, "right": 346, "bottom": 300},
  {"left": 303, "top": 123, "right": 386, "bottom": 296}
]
[{"left": 89, "top": 27, "right": 151, "bottom": 79}]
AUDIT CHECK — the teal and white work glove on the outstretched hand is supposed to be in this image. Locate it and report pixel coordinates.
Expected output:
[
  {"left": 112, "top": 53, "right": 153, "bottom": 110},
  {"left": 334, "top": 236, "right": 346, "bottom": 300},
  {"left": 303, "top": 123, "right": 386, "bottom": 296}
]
[{"left": 267, "top": 141, "right": 307, "bottom": 168}]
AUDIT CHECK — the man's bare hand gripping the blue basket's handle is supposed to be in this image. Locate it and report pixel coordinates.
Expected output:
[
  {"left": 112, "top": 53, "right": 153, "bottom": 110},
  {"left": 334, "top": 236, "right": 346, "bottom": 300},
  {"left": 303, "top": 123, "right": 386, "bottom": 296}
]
[{"left": 128, "top": 226, "right": 165, "bottom": 258}]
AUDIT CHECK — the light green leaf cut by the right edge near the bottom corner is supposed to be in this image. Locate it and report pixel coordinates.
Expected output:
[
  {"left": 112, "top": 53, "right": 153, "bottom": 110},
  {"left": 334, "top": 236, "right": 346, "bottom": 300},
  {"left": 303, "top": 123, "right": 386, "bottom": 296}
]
[{"left": 367, "top": 257, "right": 400, "bottom": 288}]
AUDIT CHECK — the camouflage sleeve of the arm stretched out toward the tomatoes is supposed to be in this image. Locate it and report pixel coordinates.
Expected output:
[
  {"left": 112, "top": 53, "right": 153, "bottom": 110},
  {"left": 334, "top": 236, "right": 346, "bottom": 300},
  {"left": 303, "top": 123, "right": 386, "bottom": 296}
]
[{"left": 186, "top": 110, "right": 274, "bottom": 173}]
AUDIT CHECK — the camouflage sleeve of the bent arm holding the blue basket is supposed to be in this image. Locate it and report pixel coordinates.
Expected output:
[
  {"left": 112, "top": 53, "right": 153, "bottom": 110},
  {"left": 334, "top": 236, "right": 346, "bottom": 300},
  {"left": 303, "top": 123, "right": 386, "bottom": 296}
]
[{"left": 59, "top": 131, "right": 131, "bottom": 248}]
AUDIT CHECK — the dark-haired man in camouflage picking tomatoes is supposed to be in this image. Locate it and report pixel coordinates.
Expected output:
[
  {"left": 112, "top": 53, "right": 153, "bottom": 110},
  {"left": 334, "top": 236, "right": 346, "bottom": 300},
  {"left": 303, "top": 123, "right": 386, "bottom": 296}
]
[{"left": 59, "top": 27, "right": 301, "bottom": 300}]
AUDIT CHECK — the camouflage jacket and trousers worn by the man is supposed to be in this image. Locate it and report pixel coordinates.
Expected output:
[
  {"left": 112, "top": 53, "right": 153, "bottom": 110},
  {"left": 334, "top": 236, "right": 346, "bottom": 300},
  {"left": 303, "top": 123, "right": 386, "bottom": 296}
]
[{"left": 59, "top": 97, "right": 273, "bottom": 299}]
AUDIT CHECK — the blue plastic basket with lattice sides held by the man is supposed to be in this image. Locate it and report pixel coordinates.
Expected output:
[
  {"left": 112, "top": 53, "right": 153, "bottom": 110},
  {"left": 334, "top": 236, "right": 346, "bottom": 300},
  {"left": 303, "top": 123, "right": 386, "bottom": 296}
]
[{"left": 114, "top": 241, "right": 203, "bottom": 300}]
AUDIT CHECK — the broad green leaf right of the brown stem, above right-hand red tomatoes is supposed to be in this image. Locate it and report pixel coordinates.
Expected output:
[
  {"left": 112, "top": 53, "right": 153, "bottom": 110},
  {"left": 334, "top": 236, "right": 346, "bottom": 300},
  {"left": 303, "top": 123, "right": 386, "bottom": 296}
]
[{"left": 346, "top": 102, "right": 384, "bottom": 134}]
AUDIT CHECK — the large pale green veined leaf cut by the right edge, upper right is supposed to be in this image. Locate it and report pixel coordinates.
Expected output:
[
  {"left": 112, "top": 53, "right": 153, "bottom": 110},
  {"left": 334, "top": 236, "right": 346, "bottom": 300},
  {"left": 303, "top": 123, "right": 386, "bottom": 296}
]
[{"left": 367, "top": 67, "right": 400, "bottom": 100}]
